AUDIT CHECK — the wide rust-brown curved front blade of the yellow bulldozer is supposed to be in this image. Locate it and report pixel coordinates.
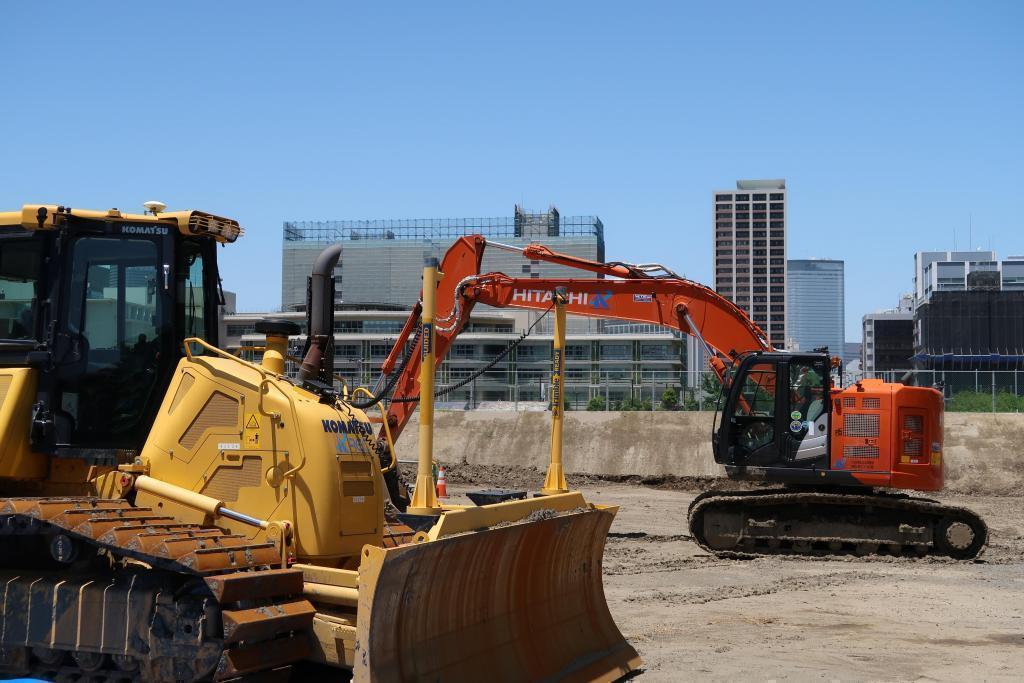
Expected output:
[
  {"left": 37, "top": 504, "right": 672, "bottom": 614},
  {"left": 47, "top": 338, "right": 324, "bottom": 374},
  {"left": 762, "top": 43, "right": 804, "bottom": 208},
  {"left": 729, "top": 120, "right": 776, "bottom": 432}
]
[{"left": 354, "top": 499, "right": 641, "bottom": 683}]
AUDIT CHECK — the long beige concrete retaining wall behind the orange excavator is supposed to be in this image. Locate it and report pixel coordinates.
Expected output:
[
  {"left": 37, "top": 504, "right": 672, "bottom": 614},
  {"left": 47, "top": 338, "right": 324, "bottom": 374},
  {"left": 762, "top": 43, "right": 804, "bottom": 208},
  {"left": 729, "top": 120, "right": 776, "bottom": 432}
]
[{"left": 398, "top": 411, "right": 1024, "bottom": 495}]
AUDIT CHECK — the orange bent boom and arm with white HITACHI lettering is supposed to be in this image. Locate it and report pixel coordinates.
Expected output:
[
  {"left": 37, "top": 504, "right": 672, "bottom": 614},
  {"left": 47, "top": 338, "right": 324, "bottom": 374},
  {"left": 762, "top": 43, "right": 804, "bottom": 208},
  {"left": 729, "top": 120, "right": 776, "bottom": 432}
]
[{"left": 378, "top": 236, "right": 772, "bottom": 448}]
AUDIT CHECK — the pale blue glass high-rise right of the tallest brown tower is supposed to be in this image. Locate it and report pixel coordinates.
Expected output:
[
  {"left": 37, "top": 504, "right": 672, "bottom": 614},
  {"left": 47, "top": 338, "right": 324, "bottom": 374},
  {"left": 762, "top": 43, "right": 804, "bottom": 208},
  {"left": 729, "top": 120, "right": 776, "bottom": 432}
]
[{"left": 785, "top": 259, "right": 847, "bottom": 362}]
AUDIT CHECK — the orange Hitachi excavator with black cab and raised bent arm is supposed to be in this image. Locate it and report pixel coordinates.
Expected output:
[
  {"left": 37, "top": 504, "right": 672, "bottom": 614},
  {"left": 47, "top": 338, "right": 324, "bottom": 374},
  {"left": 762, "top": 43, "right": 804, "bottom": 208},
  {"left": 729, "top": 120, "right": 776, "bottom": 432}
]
[{"left": 364, "top": 236, "right": 988, "bottom": 558}]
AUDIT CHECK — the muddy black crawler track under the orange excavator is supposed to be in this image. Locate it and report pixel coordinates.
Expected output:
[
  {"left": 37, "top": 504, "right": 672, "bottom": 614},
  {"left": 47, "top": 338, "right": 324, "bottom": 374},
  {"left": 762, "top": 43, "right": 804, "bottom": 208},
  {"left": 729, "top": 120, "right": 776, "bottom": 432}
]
[{"left": 688, "top": 489, "right": 988, "bottom": 559}]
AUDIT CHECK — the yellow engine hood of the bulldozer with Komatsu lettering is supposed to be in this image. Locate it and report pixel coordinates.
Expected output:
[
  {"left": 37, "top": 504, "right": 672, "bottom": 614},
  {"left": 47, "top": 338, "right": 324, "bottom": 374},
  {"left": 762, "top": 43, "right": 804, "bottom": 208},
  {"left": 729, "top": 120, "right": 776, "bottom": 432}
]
[{"left": 136, "top": 356, "right": 386, "bottom": 566}]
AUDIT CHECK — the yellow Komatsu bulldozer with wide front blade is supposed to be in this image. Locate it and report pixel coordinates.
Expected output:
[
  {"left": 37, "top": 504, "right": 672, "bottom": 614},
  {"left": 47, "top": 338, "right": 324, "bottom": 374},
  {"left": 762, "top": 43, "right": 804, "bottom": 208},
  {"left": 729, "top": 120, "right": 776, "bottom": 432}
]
[{"left": 0, "top": 203, "right": 640, "bottom": 682}]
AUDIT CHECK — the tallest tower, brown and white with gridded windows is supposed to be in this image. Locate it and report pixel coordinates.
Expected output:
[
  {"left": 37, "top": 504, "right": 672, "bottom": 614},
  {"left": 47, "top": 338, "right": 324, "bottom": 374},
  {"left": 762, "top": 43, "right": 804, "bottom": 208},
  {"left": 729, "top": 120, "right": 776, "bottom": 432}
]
[{"left": 712, "top": 180, "right": 786, "bottom": 348}]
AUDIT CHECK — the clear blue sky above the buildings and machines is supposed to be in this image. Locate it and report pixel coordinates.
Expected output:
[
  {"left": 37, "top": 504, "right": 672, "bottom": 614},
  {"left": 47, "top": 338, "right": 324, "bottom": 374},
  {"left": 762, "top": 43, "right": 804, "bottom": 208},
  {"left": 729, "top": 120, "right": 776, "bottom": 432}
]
[{"left": 0, "top": 2, "right": 1024, "bottom": 341}]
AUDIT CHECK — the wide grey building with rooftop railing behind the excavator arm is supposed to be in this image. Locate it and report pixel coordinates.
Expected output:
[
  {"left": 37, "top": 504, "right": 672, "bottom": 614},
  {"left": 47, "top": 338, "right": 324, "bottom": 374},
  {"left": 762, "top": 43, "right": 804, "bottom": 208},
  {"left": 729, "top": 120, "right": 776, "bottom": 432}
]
[{"left": 281, "top": 206, "right": 604, "bottom": 310}]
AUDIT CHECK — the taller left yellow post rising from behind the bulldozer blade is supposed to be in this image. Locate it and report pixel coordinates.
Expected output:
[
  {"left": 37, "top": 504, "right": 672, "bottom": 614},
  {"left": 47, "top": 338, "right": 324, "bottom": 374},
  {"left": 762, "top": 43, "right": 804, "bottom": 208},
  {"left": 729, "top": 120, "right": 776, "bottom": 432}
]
[{"left": 409, "top": 257, "right": 442, "bottom": 515}]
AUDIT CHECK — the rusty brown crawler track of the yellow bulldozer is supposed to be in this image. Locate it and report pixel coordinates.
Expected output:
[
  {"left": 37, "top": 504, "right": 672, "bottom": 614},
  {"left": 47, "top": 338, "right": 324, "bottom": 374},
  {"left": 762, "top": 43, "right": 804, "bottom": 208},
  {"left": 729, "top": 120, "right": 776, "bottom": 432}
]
[{"left": 0, "top": 498, "right": 314, "bottom": 682}]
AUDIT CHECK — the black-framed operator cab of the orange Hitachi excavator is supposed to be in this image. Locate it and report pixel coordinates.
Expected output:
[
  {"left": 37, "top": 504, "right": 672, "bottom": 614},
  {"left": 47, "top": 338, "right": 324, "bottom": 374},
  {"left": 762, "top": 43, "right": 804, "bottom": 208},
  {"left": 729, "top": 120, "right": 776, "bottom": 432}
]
[{"left": 714, "top": 352, "right": 829, "bottom": 469}]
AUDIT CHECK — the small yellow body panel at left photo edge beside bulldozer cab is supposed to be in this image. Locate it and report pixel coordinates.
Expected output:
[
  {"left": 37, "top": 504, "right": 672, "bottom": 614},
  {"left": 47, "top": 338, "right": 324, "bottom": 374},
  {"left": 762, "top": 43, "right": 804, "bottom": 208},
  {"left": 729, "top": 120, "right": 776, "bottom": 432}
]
[{"left": 0, "top": 368, "right": 49, "bottom": 479}]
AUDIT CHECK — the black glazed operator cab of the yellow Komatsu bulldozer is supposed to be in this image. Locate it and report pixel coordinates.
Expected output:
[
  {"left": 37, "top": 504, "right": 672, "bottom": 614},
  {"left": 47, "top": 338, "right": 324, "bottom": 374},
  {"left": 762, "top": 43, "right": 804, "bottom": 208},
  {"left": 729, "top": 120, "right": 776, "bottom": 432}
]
[{"left": 0, "top": 209, "right": 226, "bottom": 462}]
